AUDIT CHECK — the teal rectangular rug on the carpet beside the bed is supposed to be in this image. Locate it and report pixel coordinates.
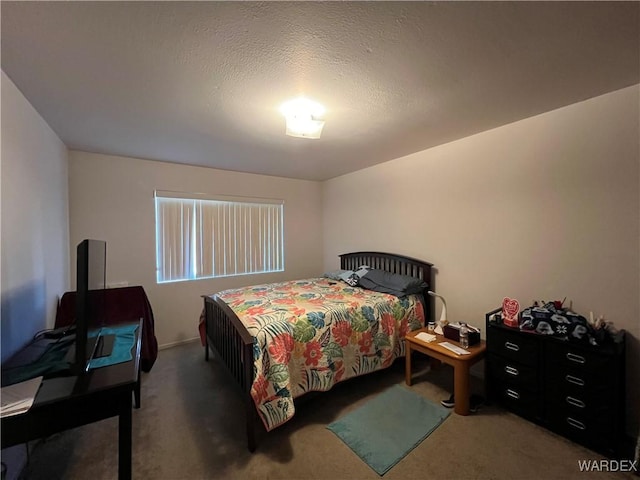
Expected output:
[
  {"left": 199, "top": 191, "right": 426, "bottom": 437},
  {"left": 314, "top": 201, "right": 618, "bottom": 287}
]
[{"left": 327, "top": 385, "right": 449, "bottom": 475}]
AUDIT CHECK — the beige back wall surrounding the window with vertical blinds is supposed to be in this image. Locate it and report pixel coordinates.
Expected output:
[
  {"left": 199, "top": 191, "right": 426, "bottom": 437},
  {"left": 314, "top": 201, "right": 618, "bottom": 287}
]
[{"left": 69, "top": 151, "right": 322, "bottom": 346}]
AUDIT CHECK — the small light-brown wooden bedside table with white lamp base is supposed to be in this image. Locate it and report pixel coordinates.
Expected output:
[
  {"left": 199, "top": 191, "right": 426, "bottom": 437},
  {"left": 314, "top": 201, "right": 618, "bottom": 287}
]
[{"left": 405, "top": 328, "right": 487, "bottom": 415}]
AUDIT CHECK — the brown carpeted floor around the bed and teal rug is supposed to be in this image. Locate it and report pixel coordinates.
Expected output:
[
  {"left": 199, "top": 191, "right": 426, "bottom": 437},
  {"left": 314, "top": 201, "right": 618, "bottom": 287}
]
[{"left": 9, "top": 343, "right": 638, "bottom": 480}]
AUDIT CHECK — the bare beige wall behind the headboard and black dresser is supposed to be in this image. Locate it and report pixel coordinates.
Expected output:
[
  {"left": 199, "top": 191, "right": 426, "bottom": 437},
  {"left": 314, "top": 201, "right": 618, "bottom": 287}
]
[{"left": 323, "top": 85, "right": 640, "bottom": 431}]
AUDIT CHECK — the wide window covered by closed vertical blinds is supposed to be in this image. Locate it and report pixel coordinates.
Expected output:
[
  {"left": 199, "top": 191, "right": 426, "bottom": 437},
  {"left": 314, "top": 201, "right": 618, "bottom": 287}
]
[{"left": 155, "top": 191, "right": 284, "bottom": 283}]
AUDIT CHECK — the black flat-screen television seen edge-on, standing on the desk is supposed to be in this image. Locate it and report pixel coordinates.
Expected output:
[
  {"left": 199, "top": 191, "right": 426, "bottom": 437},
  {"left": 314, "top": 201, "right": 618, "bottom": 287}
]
[{"left": 72, "top": 239, "right": 114, "bottom": 375}]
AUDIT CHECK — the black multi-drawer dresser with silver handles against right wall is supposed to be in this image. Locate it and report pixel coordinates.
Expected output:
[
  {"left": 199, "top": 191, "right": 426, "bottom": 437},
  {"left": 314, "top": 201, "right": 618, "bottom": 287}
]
[{"left": 486, "top": 309, "right": 625, "bottom": 457}]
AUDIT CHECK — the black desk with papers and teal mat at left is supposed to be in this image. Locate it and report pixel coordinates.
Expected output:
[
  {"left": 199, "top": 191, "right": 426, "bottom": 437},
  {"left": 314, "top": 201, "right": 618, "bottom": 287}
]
[{"left": 2, "top": 322, "right": 142, "bottom": 479}]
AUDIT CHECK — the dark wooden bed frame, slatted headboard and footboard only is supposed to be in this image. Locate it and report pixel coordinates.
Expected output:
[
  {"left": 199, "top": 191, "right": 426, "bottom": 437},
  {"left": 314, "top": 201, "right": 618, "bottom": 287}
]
[{"left": 203, "top": 252, "right": 434, "bottom": 452}]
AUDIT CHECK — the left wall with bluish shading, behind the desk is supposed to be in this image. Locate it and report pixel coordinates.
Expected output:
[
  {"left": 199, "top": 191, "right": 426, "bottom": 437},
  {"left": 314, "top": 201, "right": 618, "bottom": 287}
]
[{"left": 0, "top": 72, "right": 69, "bottom": 360}]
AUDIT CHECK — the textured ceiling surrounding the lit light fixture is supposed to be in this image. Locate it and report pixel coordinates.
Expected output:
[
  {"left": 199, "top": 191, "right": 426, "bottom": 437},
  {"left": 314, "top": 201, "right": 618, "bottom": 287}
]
[{"left": 0, "top": 1, "right": 640, "bottom": 180}]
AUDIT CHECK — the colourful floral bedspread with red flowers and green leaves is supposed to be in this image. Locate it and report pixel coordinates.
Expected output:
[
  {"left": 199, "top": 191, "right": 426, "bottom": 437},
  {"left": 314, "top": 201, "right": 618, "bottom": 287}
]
[{"left": 218, "top": 278, "right": 424, "bottom": 430}]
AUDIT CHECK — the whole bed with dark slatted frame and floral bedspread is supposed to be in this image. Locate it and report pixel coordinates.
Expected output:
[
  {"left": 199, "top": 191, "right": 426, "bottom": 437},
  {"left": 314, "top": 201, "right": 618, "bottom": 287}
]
[{"left": 203, "top": 252, "right": 434, "bottom": 452}]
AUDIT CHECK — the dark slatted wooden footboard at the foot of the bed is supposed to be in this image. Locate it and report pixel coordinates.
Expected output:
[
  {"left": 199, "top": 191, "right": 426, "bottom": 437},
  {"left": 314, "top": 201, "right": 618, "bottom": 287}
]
[{"left": 203, "top": 295, "right": 258, "bottom": 452}]
